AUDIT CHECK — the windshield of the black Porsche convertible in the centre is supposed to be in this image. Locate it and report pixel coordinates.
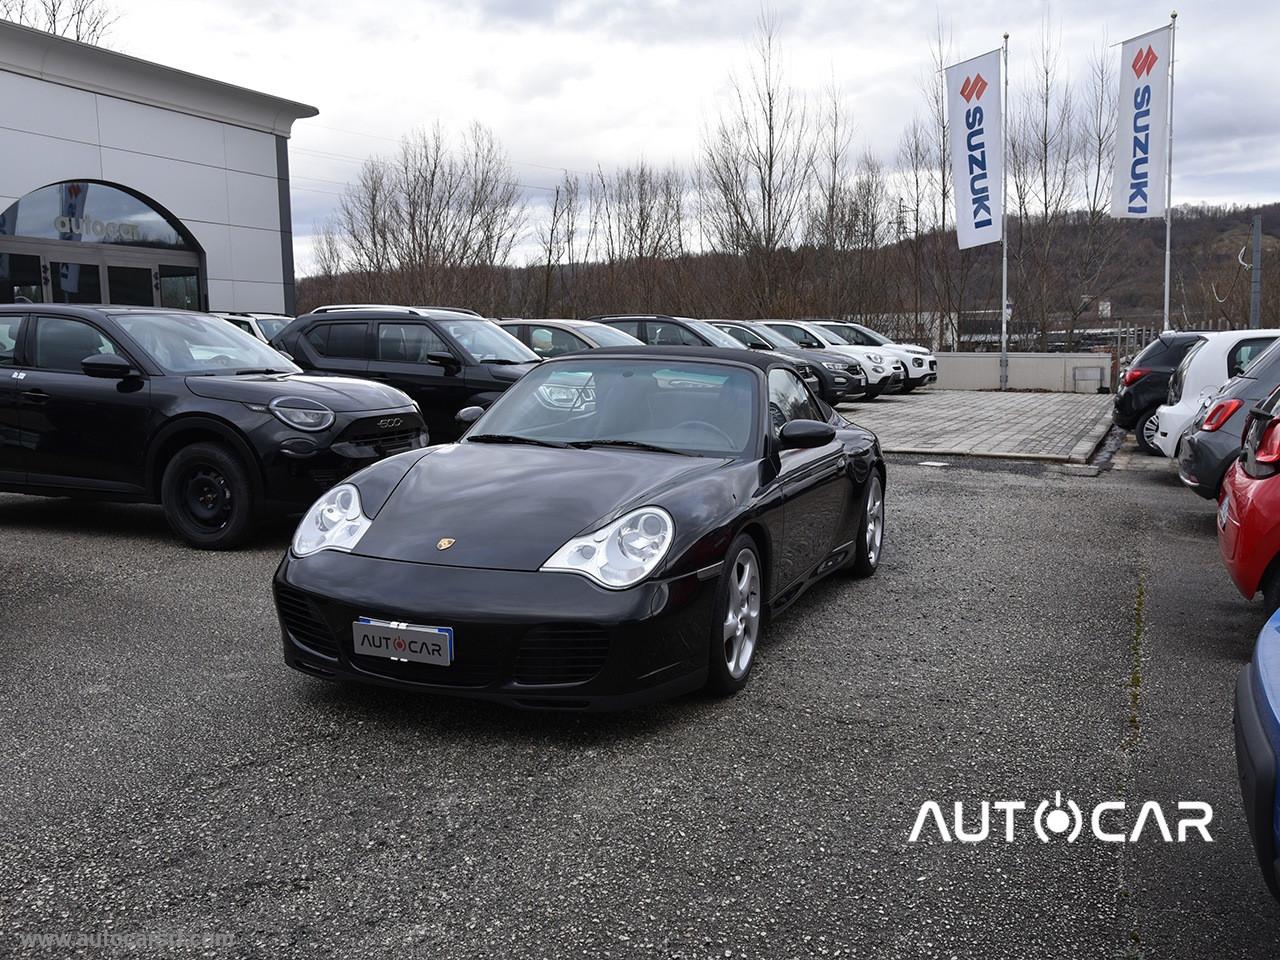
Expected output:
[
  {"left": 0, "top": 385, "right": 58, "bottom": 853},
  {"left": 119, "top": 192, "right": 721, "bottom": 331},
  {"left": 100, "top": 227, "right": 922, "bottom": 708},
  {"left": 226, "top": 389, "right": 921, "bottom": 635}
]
[{"left": 467, "top": 355, "right": 760, "bottom": 457}]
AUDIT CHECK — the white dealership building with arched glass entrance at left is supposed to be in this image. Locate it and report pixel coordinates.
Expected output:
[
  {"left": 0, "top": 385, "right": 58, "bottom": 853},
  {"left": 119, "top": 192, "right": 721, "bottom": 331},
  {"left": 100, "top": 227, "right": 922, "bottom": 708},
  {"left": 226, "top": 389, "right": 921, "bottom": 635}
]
[{"left": 0, "top": 22, "right": 317, "bottom": 314}]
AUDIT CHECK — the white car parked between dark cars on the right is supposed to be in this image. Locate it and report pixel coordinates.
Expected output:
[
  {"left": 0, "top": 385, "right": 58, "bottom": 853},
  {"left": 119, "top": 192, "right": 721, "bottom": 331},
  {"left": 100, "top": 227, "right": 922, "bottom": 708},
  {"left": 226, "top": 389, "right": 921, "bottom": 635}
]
[{"left": 1156, "top": 329, "right": 1280, "bottom": 460}]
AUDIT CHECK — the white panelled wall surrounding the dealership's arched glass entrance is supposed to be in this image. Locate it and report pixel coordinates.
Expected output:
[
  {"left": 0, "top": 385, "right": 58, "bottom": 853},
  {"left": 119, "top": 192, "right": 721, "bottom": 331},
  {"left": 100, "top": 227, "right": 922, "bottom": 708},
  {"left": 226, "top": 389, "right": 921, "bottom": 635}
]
[{"left": 0, "top": 70, "right": 292, "bottom": 312}]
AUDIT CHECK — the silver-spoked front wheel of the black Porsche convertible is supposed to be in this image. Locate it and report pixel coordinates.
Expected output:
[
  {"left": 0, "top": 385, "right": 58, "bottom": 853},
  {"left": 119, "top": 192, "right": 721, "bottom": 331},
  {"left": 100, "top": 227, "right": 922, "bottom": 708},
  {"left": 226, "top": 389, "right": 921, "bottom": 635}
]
[{"left": 707, "top": 534, "right": 764, "bottom": 696}]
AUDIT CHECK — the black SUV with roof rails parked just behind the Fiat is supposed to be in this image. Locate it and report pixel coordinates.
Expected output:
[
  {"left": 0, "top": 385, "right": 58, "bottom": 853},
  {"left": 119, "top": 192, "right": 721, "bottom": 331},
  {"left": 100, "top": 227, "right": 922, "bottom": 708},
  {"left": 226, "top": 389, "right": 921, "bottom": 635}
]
[{"left": 271, "top": 305, "right": 541, "bottom": 443}]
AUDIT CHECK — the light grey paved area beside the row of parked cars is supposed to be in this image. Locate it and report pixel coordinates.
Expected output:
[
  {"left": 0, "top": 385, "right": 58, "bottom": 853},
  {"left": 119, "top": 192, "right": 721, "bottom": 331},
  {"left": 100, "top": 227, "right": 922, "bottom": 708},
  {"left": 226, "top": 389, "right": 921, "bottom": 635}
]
[{"left": 840, "top": 389, "right": 1111, "bottom": 463}]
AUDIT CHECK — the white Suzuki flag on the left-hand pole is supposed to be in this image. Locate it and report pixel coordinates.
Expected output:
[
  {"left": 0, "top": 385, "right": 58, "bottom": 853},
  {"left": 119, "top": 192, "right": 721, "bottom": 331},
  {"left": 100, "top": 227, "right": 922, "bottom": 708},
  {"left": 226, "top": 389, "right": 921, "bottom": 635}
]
[{"left": 946, "top": 50, "right": 1005, "bottom": 250}]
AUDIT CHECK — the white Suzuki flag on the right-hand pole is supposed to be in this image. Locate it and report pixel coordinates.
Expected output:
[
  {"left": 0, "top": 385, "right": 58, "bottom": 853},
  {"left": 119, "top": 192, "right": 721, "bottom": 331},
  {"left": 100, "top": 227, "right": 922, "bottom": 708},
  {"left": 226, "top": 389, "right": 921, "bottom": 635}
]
[{"left": 1111, "top": 27, "right": 1172, "bottom": 219}]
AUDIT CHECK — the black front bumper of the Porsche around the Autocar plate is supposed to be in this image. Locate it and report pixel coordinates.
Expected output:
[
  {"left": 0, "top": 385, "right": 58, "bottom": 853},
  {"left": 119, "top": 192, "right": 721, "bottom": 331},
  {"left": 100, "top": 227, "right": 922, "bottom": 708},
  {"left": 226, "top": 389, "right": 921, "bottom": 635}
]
[{"left": 275, "top": 550, "right": 718, "bottom": 710}]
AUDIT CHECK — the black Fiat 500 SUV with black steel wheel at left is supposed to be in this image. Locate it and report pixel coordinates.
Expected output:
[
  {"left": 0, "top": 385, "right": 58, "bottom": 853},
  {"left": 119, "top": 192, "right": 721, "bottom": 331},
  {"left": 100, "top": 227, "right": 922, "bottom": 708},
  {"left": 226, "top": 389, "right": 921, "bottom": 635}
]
[{"left": 0, "top": 303, "right": 428, "bottom": 549}]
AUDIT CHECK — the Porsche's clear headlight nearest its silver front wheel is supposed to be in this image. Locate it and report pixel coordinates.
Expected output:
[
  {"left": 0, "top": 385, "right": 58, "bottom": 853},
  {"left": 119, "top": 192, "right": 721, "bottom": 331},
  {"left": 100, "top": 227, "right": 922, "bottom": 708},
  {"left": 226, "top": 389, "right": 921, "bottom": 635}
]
[{"left": 543, "top": 507, "right": 676, "bottom": 590}]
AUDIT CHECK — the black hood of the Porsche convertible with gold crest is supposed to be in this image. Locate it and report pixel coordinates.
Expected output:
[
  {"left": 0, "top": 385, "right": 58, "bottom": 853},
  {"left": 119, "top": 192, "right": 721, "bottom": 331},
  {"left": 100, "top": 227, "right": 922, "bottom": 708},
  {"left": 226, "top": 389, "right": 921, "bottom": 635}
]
[{"left": 356, "top": 443, "right": 731, "bottom": 571}]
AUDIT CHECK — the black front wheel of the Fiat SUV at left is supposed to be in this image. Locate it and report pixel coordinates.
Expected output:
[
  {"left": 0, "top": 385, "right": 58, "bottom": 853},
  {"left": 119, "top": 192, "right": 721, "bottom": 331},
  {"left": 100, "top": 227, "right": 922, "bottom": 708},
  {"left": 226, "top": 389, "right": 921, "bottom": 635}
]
[{"left": 160, "top": 443, "right": 255, "bottom": 550}]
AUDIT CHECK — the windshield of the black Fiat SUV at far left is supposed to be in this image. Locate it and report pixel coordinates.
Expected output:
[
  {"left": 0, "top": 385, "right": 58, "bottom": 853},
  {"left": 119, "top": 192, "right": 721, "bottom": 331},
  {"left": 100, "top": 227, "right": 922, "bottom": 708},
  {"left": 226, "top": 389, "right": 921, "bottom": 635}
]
[{"left": 115, "top": 314, "right": 301, "bottom": 375}]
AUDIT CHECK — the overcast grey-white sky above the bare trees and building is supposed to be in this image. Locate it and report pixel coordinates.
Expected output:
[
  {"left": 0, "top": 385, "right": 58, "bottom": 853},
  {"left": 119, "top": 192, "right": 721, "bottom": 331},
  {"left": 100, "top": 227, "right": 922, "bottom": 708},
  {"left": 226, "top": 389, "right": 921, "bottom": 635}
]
[{"left": 108, "top": 0, "right": 1280, "bottom": 273}]
